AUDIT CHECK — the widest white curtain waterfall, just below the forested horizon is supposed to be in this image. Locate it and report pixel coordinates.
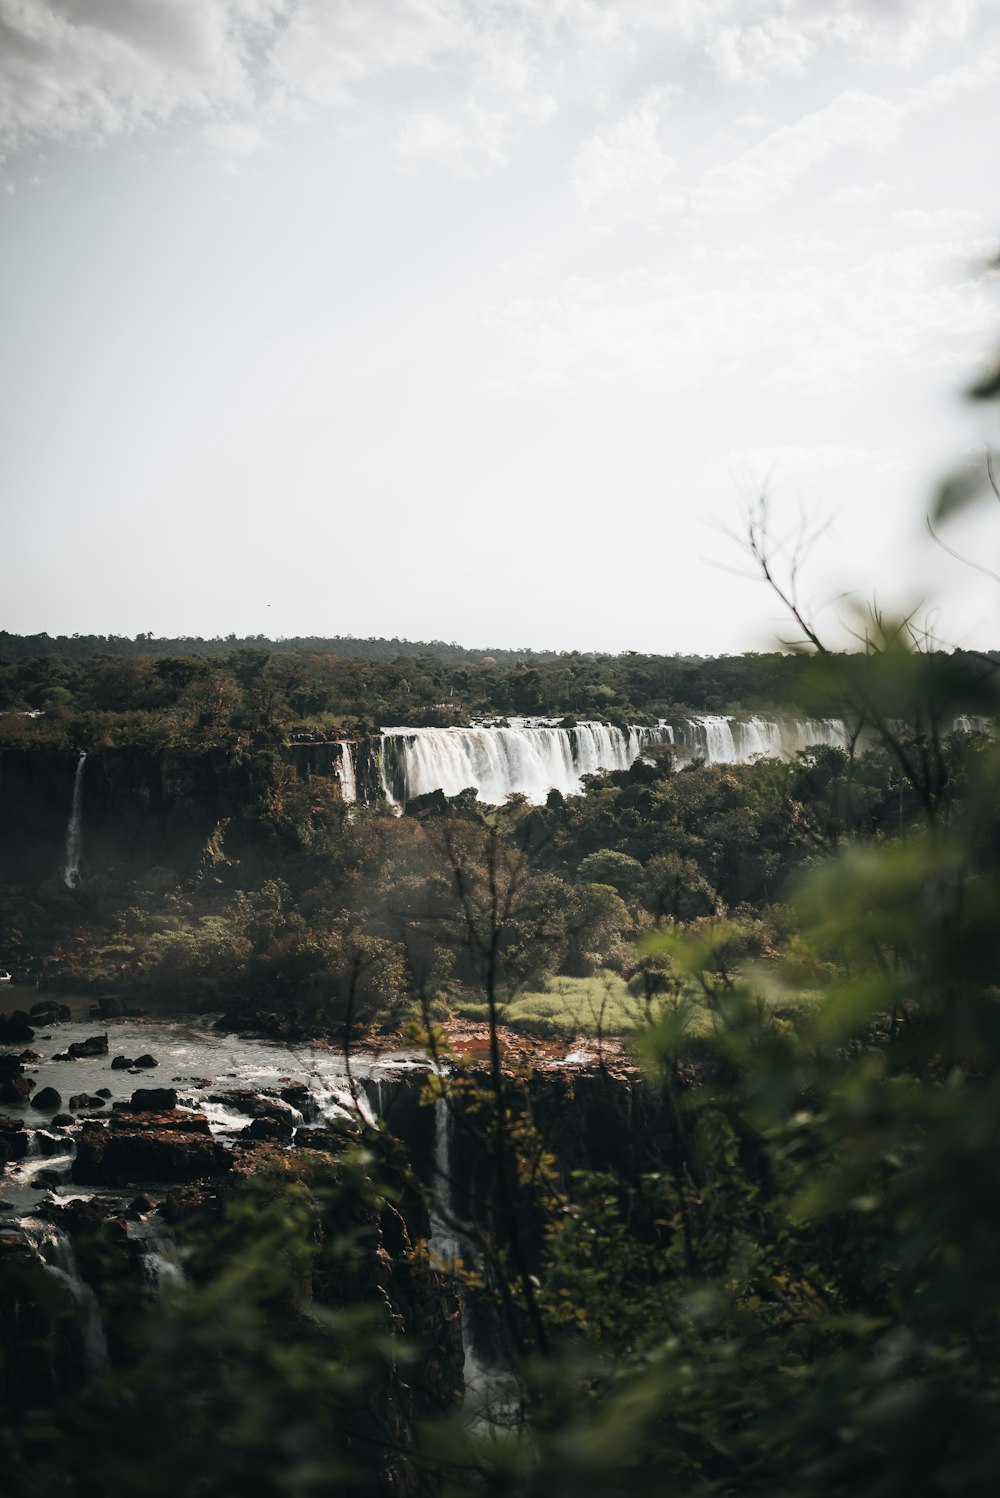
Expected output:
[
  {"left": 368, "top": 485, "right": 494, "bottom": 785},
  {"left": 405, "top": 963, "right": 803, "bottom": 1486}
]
[{"left": 380, "top": 713, "right": 847, "bottom": 806}]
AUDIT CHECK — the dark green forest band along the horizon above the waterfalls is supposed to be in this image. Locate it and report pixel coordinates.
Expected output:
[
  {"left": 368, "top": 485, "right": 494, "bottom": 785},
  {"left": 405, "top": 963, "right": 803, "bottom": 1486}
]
[{"left": 0, "top": 635, "right": 1000, "bottom": 750}]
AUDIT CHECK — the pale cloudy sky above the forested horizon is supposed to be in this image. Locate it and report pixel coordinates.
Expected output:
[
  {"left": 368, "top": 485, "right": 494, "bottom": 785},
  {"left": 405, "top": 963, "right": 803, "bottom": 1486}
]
[{"left": 0, "top": 0, "right": 1000, "bottom": 653}]
